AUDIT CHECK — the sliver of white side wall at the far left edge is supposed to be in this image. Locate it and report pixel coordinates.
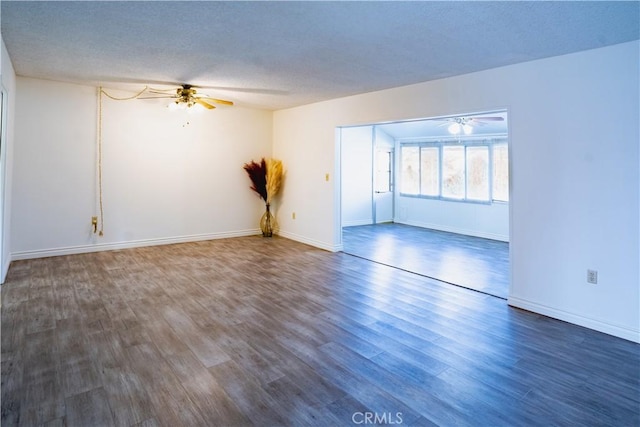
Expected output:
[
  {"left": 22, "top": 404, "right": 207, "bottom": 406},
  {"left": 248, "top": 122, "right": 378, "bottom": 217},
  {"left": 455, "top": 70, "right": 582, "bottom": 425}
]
[{"left": 0, "top": 38, "right": 16, "bottom": 283}]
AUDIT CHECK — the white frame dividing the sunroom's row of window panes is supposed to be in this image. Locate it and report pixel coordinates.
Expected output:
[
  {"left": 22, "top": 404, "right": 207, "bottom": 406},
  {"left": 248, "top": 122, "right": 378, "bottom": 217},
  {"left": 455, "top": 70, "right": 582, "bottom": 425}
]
[{"left": 398, "top": 135, "right": 509, "bottom": 205}]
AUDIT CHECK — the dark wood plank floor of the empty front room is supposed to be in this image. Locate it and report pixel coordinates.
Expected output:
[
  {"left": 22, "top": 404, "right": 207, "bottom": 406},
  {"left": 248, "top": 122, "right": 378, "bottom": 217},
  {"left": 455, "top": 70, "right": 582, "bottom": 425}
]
[{"left": 1, "top": 237, "right": 640, "bottom": 427}]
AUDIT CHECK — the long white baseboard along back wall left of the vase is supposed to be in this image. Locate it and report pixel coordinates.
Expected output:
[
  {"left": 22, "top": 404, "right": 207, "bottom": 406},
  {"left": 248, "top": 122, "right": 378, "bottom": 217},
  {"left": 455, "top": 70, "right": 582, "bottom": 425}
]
[{"left": 7, "top": 228, "right": 260, "bottom": 262}]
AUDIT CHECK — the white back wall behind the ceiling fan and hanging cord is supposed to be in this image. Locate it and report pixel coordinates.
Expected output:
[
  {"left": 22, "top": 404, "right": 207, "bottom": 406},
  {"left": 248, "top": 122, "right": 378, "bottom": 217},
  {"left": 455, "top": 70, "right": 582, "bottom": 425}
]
[{"left": 11, "top": 77, "right": 272, "bottom": 259}]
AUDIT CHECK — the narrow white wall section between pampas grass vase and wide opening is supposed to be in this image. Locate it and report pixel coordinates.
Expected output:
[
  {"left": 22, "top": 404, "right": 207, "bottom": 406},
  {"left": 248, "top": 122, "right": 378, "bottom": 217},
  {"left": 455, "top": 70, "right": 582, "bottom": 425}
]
[{"left": 273, "top": 102, "right": 344, "bottom": 250}]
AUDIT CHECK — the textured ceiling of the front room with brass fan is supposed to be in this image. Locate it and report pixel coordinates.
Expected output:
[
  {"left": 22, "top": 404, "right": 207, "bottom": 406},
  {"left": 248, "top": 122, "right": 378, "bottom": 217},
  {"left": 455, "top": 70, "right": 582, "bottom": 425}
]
[{"left": 1, "top": 0, "right": 640, "bottom": 109}]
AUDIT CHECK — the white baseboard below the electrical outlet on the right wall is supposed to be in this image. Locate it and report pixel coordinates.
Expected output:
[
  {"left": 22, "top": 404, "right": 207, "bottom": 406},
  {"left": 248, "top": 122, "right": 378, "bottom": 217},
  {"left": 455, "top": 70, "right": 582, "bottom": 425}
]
[{"left": 507, "top": 296, "right": 640, "bottom": 343}]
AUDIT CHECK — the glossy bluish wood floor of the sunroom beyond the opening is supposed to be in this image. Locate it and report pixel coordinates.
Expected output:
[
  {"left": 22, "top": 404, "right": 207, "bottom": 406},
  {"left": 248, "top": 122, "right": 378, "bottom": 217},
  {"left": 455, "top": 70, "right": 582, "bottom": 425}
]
[{"left": 342, "top": 223, "right": 510, "bottom": 299}]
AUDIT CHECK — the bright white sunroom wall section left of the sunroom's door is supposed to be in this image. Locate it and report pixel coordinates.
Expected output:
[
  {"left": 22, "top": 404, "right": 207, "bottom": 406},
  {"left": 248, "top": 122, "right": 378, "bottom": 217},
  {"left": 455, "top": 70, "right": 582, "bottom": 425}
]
[{"left": 341, "top": 126, "right": 373, "bottom": 227}]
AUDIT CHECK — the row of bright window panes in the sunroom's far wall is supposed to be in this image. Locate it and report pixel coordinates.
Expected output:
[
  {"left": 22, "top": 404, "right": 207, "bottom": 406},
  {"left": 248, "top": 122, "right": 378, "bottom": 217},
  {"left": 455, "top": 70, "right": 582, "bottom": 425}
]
[{"left": 400, "top": 138, "right": 509, "bottom": 203}]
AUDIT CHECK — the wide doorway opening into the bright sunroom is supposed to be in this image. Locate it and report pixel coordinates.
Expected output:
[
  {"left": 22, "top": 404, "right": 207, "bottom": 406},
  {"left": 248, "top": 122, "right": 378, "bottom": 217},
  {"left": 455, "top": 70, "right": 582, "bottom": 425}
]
[{"left": 340, "top": 110, "right": 510, "bottom": 299}]
